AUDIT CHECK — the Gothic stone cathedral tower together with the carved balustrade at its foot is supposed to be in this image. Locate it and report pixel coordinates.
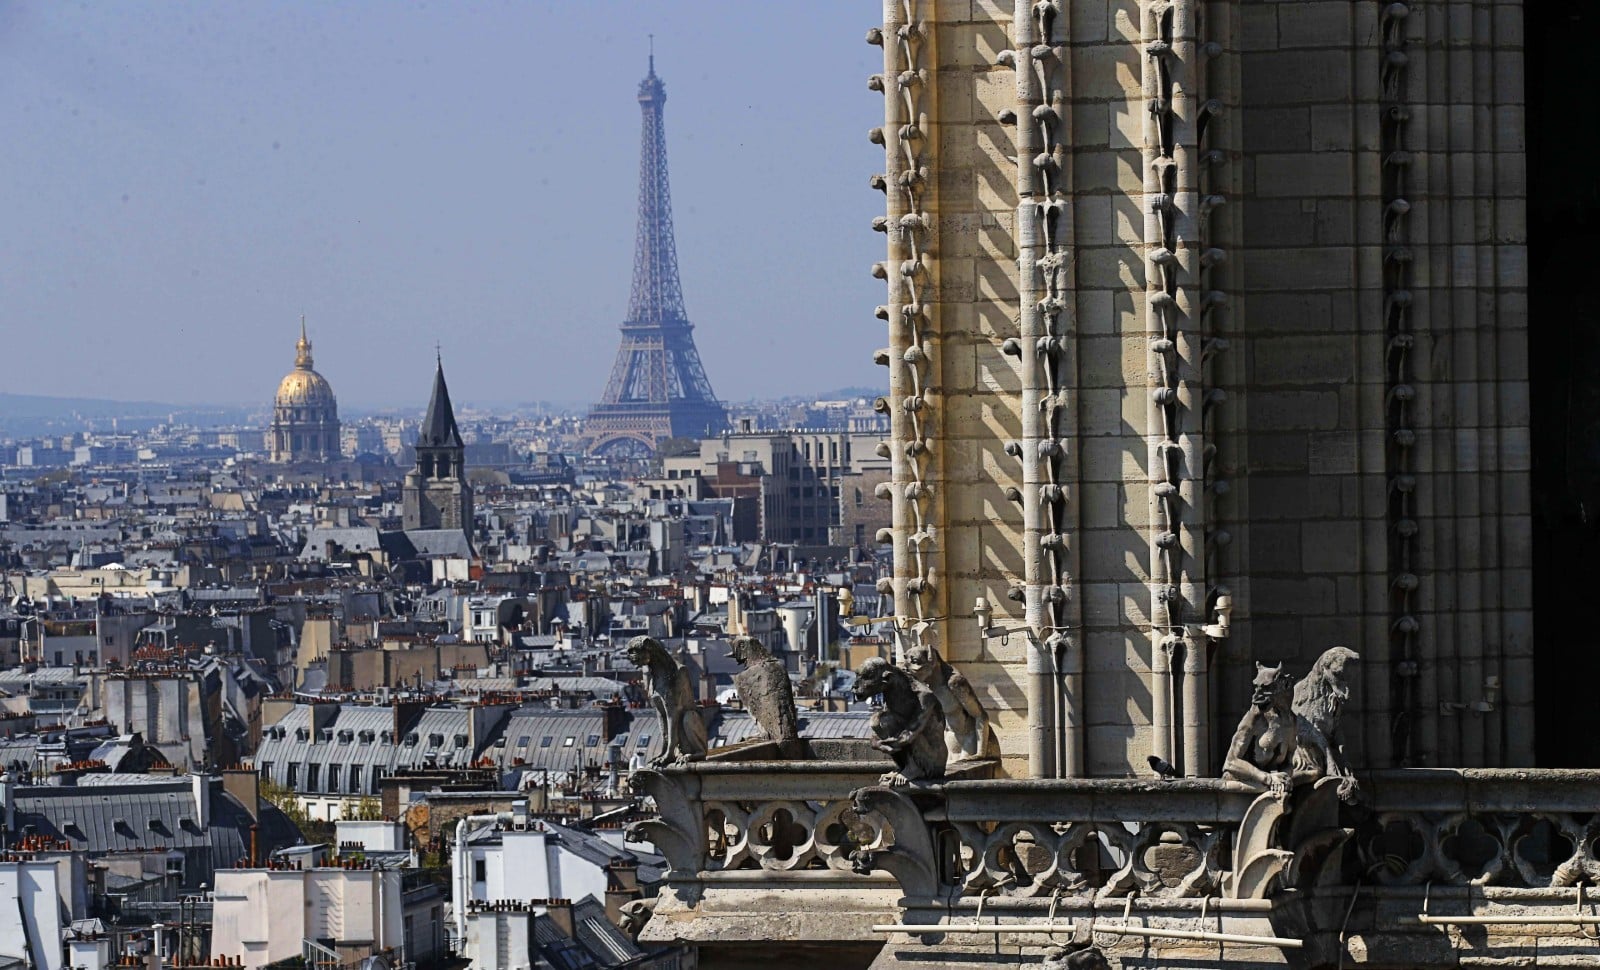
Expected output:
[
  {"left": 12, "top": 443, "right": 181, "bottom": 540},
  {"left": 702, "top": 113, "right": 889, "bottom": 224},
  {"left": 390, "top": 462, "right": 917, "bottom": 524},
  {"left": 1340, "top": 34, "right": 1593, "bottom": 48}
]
[{"left": 634, "top": 7, "right": 1600, "bottom": 970}]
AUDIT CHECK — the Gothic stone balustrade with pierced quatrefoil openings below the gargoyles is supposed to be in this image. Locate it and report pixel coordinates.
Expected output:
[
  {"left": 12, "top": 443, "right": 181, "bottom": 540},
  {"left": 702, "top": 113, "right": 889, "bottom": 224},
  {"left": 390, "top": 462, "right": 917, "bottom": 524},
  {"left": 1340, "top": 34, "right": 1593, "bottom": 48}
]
[{"left": 635, "top": 760, "right": 1600, "bottom": 967}]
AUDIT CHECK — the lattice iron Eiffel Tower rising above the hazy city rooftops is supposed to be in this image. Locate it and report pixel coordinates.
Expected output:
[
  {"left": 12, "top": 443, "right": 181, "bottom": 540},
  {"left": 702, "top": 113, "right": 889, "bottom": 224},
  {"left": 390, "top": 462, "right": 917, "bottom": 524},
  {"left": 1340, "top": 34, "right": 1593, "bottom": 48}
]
[{"left": 584, "top": 54, "right": 728, "bottom": 456}]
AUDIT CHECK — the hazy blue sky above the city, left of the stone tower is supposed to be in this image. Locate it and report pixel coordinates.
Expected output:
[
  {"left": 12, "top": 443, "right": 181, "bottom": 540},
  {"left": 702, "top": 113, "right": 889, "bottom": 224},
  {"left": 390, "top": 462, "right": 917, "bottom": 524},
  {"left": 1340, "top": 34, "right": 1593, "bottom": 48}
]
[{"left": 0, "top": 0, "right": 883, "bottom": 407}]
